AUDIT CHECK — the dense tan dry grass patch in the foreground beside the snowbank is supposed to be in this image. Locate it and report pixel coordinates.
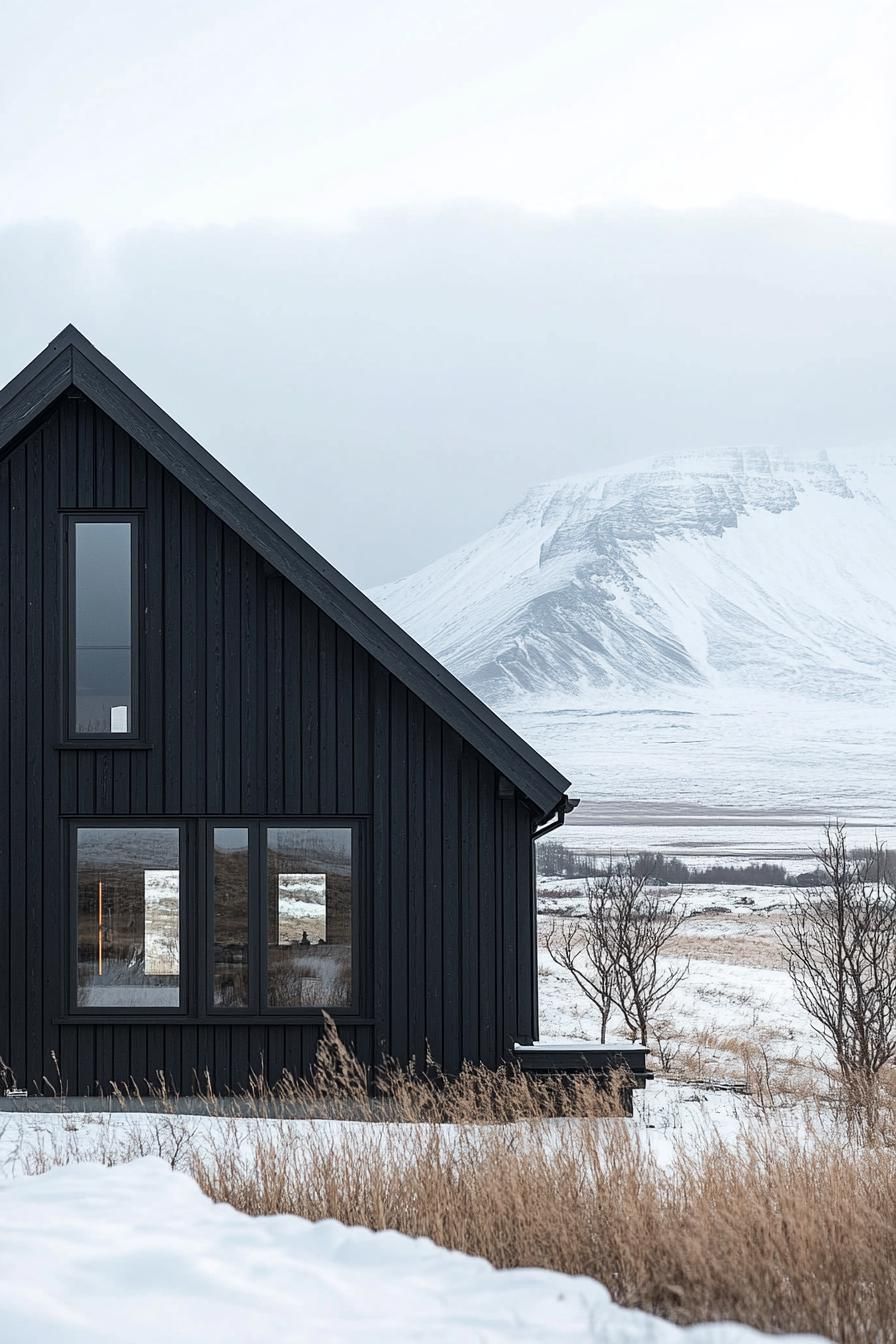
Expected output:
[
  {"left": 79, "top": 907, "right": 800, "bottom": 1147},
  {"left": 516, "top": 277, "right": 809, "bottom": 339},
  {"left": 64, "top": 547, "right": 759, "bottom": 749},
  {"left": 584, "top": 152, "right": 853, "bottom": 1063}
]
[{"left": 192, "top": 1122, "right": 896, "bottom": 1344}]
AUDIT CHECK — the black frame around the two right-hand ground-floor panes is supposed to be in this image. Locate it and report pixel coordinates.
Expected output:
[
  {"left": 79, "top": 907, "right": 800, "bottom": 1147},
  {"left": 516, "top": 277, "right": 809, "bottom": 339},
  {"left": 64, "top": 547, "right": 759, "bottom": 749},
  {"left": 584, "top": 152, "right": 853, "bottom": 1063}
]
[{"left": 203, "top": 814, "right": 367, "bottom": 1024}]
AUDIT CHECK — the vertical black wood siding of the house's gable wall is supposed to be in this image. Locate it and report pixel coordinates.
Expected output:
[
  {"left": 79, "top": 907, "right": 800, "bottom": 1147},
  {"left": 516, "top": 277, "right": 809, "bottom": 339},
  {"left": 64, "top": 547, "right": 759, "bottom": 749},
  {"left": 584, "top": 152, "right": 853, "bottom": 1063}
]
[{"left": 0, "top": 396, "right": 536, "bottom": 1094}]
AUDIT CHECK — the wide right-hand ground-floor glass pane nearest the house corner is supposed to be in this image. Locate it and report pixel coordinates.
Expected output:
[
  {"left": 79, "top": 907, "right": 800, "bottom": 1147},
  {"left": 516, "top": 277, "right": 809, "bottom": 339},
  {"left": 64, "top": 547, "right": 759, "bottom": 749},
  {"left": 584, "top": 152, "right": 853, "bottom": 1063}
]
[{"left": 267, "top": 827, "right": 352, "bottom": 1008}]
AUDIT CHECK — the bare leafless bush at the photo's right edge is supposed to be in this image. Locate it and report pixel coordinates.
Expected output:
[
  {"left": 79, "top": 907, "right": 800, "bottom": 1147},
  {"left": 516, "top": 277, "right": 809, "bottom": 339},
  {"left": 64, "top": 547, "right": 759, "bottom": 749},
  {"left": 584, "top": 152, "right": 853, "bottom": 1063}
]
[{"left": 778, "top": 825, "right": 896, "bottom": 1090}]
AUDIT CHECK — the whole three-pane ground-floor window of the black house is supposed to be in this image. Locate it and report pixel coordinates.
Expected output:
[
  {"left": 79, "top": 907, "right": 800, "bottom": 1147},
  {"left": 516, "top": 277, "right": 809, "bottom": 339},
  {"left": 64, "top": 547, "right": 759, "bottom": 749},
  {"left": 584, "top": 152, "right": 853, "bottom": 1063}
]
[{"left": 73, "top": 818, "right": 359, "bottom": 1016}]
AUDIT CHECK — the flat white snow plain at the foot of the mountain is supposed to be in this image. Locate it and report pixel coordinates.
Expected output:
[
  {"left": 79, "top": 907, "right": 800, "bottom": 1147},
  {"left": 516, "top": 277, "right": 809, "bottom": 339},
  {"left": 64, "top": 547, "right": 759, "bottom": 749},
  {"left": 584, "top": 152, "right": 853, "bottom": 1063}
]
[{"left": 501, "top": 688, "right": 896, "bottom": 825}]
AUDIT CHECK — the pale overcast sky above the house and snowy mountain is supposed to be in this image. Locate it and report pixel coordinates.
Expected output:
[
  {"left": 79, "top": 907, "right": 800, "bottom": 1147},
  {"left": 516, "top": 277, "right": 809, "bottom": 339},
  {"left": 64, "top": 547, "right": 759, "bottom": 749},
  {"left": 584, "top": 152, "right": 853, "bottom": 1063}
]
[{"left": 0, "top": 0, "right": 896, "bottom": 585}]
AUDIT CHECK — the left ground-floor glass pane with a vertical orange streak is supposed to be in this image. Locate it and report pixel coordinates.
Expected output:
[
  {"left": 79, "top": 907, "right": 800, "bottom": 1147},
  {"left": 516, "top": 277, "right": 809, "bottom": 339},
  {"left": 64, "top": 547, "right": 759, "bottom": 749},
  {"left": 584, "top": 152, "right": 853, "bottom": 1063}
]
[{"left": 78, "top": 827, "right": 180, "bottom": 1008}]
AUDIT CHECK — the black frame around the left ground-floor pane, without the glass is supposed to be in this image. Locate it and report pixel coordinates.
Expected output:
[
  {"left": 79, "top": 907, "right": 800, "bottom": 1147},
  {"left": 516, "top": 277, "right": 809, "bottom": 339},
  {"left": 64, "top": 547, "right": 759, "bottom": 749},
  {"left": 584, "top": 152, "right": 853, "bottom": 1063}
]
[{"left": 64, "top": 816, "right": 195, "bottom": 1023}]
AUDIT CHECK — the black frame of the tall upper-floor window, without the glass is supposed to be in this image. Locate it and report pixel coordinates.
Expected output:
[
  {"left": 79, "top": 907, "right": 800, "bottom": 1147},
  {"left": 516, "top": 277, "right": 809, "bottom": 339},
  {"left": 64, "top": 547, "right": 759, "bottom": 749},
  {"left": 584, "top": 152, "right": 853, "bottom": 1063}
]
[{"left": 60, "top": 508, "right": 145, "bottom": 747}]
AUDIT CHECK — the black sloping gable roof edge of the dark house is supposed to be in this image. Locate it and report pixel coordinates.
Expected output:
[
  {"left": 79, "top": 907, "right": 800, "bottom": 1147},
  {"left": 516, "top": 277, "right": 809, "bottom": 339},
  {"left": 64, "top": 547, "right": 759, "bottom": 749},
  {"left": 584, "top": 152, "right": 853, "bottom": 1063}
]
[{"left": 0, "top": 327, "right": 570, "bottom": 816}]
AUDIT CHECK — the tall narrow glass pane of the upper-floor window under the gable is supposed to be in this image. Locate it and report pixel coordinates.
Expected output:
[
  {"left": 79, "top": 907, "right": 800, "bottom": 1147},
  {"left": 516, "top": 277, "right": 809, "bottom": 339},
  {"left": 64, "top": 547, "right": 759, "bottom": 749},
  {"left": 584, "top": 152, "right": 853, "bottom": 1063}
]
[{"left": 73, "top": 519, "right": 134, "bottom": 737}]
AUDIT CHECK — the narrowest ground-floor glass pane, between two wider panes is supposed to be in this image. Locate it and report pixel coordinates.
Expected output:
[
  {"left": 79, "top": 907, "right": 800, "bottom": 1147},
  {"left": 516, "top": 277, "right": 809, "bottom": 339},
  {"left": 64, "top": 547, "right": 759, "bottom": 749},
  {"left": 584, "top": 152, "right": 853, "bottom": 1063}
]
[{"left": 212, "top": 827, "right": 249, "bottom": 1008}]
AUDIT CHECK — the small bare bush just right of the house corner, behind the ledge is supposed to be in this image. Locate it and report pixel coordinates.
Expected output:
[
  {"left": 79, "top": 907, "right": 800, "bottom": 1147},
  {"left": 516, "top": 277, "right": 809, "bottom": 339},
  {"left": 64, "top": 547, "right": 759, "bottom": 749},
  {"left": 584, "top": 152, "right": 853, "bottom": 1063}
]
[{"left": 545, "top": 856, "right": 689, "bottom": 1048}]
